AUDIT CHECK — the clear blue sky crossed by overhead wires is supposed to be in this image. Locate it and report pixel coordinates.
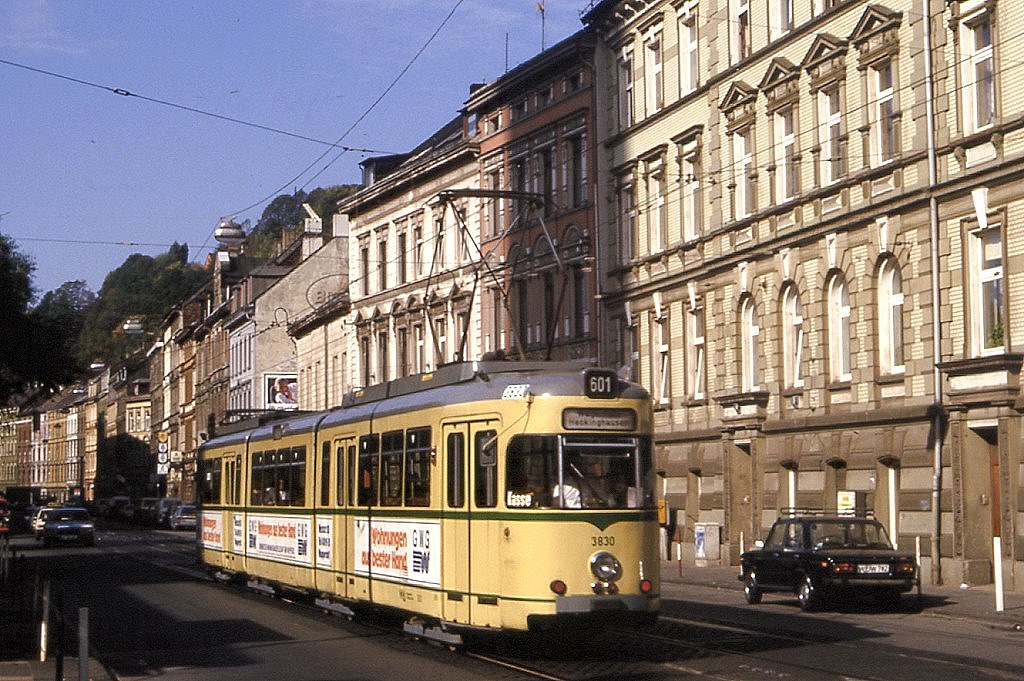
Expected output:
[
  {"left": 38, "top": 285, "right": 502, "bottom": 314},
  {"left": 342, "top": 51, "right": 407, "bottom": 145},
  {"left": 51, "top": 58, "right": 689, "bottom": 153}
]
[{"left": 0, "top": 0, "right": 589, "bottom": 294}]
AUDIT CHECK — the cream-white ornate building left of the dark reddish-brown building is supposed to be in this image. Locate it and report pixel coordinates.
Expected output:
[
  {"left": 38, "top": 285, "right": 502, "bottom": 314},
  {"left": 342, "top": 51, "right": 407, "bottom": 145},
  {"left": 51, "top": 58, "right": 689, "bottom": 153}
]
[{"left": 338, "top": 117, "right": 480, "bottom": 387}]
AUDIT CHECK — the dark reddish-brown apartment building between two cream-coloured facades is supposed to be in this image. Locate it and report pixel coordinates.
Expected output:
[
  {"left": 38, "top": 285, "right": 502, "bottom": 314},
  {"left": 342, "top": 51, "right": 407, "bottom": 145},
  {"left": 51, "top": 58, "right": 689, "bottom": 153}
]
[{"left": 462, "top": 31, "right": 600, "bottom": 359}]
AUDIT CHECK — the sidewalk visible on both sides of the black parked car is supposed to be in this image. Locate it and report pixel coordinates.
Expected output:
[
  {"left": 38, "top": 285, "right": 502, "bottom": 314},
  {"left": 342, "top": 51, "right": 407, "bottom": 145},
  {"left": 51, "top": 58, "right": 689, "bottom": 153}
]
[{"left": 662, "top": 561, "right": 1024, "bottom": 632}]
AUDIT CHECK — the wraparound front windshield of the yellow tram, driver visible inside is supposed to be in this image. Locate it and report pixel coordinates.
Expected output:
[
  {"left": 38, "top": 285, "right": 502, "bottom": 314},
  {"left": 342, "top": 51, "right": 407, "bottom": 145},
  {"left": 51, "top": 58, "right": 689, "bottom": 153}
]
[{"left": 505, "top": 435, "right": 654, "bottom": 509}]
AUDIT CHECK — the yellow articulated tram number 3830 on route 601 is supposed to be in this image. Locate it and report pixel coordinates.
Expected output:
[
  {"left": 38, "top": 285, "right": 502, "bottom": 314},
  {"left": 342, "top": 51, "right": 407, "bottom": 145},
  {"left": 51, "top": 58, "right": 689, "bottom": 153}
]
[{"left": 197, "top": 361, "right": 659, "bottom": 644}]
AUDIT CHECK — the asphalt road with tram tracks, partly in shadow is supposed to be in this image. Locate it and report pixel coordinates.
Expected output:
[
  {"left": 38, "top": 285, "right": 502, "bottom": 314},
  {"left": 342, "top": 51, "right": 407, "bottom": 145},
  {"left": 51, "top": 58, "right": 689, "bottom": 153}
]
[{"left": 9, "top": 528, "right": 1024, "bottom": 681}]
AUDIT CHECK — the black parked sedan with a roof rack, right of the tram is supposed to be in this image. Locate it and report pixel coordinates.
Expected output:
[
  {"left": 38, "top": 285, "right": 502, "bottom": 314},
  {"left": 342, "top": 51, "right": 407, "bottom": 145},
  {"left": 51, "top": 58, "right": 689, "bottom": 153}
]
[{"left": 739, "top": 514, "right": 918, "bottom": 610}]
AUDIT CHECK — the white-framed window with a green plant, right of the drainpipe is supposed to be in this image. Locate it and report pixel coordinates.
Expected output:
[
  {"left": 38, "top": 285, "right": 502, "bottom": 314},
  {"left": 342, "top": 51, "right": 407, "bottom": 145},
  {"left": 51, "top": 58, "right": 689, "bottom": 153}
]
[{"left": 971, "top": 223, "right": 1006, "bottom": 354}]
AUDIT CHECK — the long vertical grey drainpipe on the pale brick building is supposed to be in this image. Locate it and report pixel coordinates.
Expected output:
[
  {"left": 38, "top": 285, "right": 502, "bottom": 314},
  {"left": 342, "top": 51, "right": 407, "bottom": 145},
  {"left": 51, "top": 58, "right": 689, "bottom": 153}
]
[{"left": 922, "top": 0, "right": 943, "bottom": 585}]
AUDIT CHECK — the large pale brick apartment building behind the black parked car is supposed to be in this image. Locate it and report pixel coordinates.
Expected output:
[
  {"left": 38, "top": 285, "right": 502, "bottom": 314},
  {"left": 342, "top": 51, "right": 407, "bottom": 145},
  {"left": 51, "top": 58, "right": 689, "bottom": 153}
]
[{"left": 585, "top": 0, "right": 1024, "bottom": 589}]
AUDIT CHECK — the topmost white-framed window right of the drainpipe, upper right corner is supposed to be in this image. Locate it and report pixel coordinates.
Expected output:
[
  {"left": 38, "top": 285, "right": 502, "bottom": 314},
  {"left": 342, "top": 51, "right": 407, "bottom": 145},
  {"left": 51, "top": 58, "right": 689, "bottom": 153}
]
[{"left": 959, "top": 8, "right": 995, "bottom": 134}]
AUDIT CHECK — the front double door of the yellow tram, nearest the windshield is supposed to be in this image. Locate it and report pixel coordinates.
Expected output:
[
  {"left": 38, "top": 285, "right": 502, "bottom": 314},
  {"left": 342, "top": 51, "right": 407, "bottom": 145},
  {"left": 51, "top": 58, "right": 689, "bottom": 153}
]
[{"left": 441, "top": 420, "right": 500, "bottom": 625}]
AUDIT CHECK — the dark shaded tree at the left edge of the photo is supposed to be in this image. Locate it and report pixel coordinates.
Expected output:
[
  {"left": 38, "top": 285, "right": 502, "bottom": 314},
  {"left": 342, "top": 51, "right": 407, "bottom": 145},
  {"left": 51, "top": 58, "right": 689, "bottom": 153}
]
[{"left": 0, "top": 233, "right": 35, "bottom": 401}]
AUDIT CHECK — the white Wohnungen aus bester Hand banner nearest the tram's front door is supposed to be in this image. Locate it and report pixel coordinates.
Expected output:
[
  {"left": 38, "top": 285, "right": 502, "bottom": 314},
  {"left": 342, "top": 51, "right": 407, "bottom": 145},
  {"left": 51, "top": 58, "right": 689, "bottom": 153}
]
[{"left": 354, "top": 518, "right": 441, "bottom": 586}]
